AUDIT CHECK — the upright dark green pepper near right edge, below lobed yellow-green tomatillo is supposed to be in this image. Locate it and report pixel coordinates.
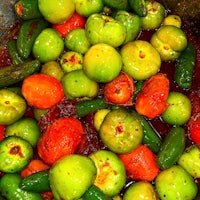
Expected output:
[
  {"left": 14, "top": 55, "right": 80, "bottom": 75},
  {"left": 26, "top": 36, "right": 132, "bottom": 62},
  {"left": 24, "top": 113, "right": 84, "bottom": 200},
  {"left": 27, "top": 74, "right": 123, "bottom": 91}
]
[{"left": 174, "top": 42, "right": 196, "bottom": 89}]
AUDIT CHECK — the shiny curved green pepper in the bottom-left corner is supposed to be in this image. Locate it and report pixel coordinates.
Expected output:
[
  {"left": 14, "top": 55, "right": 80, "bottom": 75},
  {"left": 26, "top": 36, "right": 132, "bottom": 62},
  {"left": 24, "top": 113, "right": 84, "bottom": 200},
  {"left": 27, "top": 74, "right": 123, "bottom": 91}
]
[{"left": 0, "top": 173, "right": 43, "bottom": 200}]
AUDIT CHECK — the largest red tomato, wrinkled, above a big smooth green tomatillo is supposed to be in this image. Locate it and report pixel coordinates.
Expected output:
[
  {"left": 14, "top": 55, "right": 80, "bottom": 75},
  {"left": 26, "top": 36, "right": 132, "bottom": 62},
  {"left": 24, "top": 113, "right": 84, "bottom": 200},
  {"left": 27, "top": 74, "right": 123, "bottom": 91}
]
[{"left": 37, "top": 117, "right": 85, "bottom": 165}]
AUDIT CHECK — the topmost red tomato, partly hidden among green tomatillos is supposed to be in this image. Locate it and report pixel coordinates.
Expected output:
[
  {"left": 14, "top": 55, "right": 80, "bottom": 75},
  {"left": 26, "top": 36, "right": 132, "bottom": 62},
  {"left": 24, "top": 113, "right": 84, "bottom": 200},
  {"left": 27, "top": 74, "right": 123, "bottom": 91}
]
[{"left": 52, "top": 12, "right": 86, "bottom": 38}]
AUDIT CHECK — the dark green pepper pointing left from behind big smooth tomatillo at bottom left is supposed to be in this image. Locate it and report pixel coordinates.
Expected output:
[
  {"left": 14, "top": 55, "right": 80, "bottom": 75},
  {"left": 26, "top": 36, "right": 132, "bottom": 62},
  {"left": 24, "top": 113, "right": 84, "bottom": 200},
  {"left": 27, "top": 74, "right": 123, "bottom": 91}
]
[{"left": 19, "top": 170, "right": 51, "bottom": 192}]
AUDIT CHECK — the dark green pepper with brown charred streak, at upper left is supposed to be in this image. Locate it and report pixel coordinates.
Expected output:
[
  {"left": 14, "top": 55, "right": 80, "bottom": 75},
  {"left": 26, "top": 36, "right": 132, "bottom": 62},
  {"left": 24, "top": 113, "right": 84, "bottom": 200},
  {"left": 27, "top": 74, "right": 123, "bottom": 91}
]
[{"left": 17, "top": 18, "right": 49, "bottom": 59}]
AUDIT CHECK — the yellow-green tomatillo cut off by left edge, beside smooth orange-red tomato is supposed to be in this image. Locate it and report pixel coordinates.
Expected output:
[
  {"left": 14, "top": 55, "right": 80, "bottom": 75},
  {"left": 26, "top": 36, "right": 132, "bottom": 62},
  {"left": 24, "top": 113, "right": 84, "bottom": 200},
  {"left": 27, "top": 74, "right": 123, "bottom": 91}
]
[{"left": 0, "top": 89, "right": 27, "bottom": 125}]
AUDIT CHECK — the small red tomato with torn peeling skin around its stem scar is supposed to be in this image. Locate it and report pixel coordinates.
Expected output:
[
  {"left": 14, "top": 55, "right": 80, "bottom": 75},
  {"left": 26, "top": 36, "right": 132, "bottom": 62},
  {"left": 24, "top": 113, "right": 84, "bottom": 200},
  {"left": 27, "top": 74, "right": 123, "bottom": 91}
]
[{"left": 104, "top": 72, "right": 135, "bottom": 106}]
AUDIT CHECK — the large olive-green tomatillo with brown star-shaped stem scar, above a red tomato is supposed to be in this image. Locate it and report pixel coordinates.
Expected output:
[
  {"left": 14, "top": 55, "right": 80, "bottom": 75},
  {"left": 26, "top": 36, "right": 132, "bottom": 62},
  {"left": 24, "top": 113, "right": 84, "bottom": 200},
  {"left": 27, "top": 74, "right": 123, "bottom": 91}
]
[{"left": 99, "top": 109, "right": 143, "bottom": 154}]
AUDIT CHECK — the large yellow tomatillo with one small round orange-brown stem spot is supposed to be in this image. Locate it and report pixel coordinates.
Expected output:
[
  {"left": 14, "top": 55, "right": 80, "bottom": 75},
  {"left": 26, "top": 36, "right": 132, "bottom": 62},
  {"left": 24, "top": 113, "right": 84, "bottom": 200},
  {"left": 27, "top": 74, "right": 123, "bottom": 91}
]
[{"left": 120, "top": 40, "right": 161, "bottom": 80}]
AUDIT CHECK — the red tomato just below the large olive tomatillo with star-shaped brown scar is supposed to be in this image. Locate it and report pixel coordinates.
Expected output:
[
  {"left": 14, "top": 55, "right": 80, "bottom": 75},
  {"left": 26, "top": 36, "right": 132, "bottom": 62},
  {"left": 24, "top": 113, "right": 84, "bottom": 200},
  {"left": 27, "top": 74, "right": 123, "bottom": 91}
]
[{"left": 119, "top": 144, "right": 159, "bottom": 182}]
